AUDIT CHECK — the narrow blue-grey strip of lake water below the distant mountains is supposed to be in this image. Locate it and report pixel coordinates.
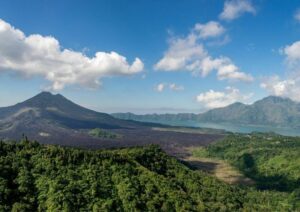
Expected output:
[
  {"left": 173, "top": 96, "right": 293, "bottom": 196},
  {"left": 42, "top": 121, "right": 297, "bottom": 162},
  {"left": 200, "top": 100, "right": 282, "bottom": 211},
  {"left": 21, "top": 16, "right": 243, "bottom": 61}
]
[{"left": 152, "top": 121, "right": 300, "bottom": 136}]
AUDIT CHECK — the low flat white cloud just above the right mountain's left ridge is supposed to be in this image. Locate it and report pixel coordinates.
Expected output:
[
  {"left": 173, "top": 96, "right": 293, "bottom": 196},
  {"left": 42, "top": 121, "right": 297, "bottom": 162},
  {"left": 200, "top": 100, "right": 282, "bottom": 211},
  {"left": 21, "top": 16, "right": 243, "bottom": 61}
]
[{"left": 196, "top": 87, "right": 253, "bottom": 109}]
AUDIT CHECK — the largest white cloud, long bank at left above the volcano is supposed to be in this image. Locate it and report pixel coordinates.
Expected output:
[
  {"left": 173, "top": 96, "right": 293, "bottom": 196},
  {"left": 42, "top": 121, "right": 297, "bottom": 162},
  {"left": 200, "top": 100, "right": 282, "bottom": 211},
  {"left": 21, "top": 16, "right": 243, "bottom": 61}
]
[{"left": 0, "top": 19, "right": 144, "bottom": 90}]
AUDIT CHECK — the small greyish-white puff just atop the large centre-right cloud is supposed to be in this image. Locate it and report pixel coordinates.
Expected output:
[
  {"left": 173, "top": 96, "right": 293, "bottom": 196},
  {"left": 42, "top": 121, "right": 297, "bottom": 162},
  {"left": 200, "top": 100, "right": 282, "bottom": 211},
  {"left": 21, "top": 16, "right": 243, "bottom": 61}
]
[{"left": 194, "top": 21, "right": 225, "bottom": 39}]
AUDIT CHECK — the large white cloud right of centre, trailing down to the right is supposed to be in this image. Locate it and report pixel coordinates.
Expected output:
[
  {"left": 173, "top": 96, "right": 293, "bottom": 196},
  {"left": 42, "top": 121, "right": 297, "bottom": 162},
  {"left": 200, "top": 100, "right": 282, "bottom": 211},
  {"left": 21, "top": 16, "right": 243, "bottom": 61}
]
[{"left": 154, "top": 22, "right": 253, "bottom": 81}]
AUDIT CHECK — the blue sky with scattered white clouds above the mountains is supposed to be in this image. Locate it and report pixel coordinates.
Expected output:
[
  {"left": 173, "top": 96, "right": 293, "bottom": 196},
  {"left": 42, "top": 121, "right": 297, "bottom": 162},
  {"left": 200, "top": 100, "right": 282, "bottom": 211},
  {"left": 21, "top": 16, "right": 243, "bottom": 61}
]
[{"left": 0, "top": 0, "right": 300, "bottom": 114}]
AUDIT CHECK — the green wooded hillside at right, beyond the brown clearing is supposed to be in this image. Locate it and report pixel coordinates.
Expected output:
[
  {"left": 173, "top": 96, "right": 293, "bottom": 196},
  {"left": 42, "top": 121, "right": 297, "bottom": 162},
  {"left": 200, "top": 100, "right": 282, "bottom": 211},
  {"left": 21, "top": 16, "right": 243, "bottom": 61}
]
[{"left": 194, "top": 133, "right": 300, "bottom": 208}]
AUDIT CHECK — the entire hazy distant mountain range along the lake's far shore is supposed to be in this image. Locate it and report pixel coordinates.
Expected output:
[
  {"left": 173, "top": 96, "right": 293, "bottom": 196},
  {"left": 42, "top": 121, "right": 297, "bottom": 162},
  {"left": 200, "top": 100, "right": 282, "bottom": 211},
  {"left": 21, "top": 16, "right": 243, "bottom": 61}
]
[{"left": 112, "top": 96, "right": 300, "bottom": 128}]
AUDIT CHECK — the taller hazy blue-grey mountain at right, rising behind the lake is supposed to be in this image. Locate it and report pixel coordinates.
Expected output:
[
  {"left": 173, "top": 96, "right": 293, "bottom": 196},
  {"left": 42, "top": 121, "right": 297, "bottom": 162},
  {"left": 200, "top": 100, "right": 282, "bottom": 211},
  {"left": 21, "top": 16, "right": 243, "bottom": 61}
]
[{"left": 197, "top": 96, "right": 300, "bottom": 127}]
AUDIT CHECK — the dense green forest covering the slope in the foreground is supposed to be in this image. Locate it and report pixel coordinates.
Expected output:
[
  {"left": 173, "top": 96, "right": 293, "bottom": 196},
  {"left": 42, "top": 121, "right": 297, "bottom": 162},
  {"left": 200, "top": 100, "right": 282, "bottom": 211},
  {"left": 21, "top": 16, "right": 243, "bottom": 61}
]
[{"left": 0, "top": 139, "right": 299, "bottom": 211}]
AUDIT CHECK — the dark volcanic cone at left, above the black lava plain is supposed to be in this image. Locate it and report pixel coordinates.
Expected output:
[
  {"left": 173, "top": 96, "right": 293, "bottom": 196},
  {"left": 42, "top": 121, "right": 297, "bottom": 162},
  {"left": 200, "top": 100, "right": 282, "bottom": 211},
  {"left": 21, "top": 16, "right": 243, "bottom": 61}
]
[{"left": 0, "top": 92, "right": 141, "bottom": 130}]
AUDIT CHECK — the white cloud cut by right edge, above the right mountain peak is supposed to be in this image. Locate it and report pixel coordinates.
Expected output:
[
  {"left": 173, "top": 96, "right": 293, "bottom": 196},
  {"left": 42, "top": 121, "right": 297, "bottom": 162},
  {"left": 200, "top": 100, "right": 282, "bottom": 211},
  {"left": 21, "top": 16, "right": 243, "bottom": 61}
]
[{"left": 261, "top": 41, "right": 300, "bottom": 101}]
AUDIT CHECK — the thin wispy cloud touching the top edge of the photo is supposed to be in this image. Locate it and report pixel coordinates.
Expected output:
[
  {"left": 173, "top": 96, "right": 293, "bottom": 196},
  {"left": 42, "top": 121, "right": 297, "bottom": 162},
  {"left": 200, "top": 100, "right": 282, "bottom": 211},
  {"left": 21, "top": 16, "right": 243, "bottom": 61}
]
[{"left": 219, "top": 0, "right": 256, "bottom": 21}]
